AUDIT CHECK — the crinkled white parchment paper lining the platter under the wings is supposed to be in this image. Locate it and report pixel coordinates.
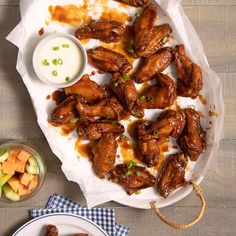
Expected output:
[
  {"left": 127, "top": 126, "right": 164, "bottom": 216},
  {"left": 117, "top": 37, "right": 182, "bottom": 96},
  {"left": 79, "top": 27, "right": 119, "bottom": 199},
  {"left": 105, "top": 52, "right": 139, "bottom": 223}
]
[{"left": 7, "top": 0, "right": 224, "bottom": 208}]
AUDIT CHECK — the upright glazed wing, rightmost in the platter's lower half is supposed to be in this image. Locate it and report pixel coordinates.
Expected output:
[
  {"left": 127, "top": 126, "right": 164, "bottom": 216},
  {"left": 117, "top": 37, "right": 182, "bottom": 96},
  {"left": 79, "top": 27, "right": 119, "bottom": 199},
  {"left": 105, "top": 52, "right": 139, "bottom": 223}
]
[{"left": 178, "top": 108, "right": 206, "bottom": 161}]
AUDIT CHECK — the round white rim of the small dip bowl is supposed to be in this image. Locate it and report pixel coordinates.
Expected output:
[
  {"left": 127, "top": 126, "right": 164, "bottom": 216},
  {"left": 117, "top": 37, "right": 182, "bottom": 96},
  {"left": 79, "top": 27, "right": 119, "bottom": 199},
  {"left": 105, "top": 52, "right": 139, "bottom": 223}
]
[{"left": 33, "top": 33, "right": 87, "bottom": 88}]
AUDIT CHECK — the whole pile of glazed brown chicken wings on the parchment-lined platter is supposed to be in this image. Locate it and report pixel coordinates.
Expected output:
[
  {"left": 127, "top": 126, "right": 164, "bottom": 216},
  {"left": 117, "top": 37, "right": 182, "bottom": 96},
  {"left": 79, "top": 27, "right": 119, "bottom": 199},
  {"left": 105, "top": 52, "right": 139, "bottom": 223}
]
[{"left": 49, "top": 0, "right": 206, "bottom": 198}]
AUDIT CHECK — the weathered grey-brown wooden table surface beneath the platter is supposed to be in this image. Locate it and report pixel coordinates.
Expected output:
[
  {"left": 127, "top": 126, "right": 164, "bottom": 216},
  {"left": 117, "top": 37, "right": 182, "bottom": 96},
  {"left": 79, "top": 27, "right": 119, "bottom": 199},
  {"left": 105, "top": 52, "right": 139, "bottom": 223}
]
[{"left": 0, "top": 0, "right": 236, "bottom": 236}]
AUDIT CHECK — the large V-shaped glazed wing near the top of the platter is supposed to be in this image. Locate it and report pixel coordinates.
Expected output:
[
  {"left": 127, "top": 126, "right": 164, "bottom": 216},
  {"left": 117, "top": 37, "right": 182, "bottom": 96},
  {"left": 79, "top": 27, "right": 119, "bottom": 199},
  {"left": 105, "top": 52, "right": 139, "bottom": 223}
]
[{"left": 134, "top": 4, "right": 172, "bottom": 57}]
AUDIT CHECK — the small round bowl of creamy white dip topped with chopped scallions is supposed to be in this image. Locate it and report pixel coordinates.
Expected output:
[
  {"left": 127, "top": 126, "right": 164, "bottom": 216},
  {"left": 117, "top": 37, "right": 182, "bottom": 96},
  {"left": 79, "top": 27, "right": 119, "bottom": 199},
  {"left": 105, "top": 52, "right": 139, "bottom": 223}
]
[{"left": 33, "top": 33, "right": 87, "bottom": 88}]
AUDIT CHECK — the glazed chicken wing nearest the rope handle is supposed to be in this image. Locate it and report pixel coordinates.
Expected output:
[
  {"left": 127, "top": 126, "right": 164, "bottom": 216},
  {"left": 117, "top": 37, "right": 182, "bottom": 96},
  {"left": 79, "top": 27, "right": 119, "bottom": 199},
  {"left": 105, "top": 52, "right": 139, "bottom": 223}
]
[{"left": 156, "top": 153, "right": 188, "bottom": 198}]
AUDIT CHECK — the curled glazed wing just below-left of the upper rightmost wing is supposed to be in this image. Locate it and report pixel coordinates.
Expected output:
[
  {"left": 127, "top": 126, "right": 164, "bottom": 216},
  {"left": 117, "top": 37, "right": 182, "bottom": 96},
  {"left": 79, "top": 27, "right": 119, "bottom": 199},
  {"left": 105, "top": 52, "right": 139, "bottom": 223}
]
[{"left": 140, "top": 74, "right": 177, "bottom": 109}]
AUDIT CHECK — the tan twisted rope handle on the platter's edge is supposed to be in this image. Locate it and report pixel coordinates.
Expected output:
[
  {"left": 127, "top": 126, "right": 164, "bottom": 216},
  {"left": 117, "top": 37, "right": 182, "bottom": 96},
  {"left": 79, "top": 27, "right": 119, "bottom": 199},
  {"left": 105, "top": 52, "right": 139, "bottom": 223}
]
[{"left": 150, "top": 181, "right": 206, "bottom": 229}]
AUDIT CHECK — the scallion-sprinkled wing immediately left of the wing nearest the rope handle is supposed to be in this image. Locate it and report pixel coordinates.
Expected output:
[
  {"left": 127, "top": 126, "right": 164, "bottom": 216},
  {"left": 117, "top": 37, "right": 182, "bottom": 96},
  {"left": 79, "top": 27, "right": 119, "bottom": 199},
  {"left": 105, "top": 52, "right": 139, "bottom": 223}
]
[{"left": 110, "top": 164, "right": 156, "bottom": 195}]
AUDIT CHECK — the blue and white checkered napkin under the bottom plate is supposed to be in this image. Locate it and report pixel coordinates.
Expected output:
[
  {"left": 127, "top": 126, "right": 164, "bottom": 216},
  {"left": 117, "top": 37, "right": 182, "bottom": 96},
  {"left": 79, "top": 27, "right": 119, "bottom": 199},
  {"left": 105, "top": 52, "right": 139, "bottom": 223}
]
[{"left": 31, "top": 194, "right": 129, "bottom": 236}]
